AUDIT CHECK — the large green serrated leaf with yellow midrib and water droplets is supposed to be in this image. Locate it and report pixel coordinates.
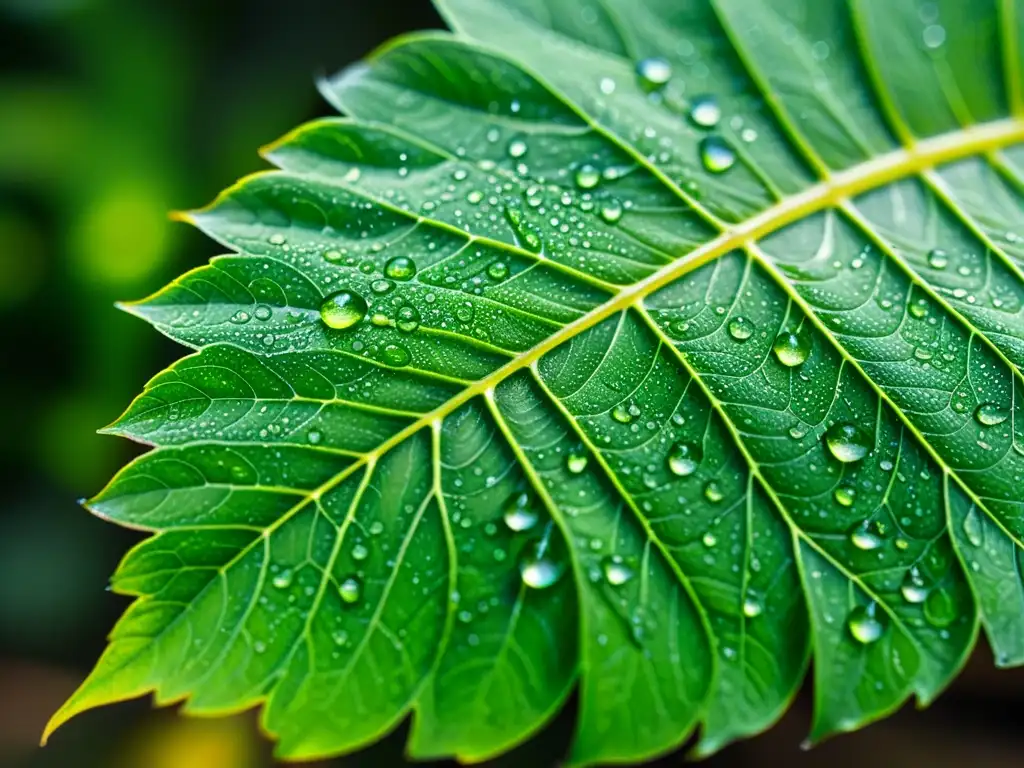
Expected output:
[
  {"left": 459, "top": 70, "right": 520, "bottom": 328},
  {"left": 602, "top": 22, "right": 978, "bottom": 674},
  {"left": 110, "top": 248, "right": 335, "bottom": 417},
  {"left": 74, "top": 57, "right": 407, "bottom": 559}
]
[{"left": 47, "top": 0, "right": 1024, "bottom": 765}]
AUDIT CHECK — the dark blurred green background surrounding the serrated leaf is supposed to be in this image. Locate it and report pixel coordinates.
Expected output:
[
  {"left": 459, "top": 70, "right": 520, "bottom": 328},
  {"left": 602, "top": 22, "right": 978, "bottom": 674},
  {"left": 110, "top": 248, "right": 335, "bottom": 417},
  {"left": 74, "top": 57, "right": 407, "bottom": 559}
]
[{"left": 0, "top": 0, "right": 1024, "bottom": 768}]
